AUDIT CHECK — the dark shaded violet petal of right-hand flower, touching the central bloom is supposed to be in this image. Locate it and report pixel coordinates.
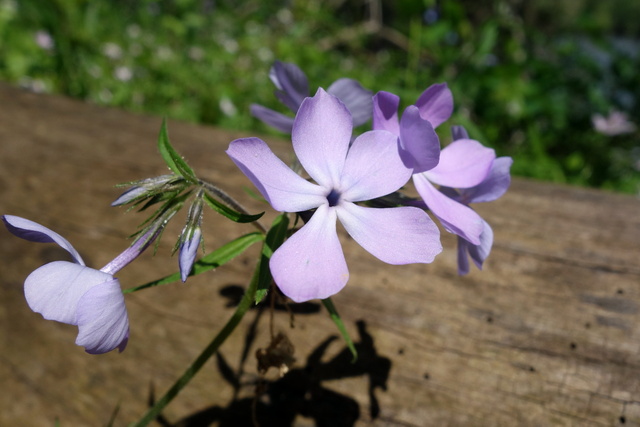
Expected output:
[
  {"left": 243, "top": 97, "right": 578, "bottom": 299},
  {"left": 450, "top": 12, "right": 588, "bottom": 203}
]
[{"left": 400, "top": 105, "right": 440, "bottom": 173}]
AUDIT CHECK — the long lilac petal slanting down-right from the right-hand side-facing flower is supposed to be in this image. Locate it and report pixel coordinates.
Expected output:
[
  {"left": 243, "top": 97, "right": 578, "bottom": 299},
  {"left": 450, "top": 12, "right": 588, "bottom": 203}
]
[{"left": 413, "top": 174, "right": 483, "bottom": 245}]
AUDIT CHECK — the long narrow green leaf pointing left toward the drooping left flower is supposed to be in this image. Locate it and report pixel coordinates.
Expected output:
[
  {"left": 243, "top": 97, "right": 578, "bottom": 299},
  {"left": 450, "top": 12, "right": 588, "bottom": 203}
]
[{"left": 122, "top": 231, "right": 264, "bottom": 294}]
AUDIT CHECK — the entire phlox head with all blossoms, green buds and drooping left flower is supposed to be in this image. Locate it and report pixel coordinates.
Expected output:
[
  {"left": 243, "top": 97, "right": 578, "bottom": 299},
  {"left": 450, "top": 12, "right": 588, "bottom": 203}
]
[{"left": 3, "top": 62, "right": 512, "bottom": 354}]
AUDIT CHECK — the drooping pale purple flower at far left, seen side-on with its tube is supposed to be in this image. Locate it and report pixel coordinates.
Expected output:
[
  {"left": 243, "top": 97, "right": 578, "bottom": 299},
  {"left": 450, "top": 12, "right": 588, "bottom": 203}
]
[{"left": 2, "top": 215, "right": 152, "bottom": 354}]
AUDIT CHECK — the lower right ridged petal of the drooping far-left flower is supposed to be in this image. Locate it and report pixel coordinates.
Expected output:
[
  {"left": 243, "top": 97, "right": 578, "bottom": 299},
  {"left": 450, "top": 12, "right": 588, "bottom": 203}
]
[{"left": 76, "top": 278, "right": 129, "bottom": 354}]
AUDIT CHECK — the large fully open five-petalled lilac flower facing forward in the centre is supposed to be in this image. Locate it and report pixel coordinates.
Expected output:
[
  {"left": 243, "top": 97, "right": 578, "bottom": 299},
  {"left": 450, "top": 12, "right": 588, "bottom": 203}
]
[{"left": 227, "top": 89, "right": 442, "bottom": 302}]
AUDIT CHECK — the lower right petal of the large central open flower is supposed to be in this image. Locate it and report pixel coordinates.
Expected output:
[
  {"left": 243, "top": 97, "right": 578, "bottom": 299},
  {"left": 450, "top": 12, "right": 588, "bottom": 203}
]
[{"left": 337, "top": 203, "right": 442, "bottom": 265}]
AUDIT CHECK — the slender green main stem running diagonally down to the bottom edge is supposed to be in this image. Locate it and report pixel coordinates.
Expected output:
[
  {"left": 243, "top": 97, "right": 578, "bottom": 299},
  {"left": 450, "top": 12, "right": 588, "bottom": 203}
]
[{"left": 130, "top": 254, "right": 260, "bottom": 427}]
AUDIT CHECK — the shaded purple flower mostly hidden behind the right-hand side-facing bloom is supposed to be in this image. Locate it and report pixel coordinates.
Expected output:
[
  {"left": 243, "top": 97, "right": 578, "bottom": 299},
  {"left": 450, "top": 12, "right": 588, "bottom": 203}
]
[{"left": 440, "top": 157, "right": 513, "bottom": 275}]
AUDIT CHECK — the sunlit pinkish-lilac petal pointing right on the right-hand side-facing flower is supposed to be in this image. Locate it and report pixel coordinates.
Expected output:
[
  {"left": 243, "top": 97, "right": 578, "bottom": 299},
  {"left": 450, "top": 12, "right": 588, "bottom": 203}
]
[{"left": 425, "top": 139, "right": 496, "bottom": 188}]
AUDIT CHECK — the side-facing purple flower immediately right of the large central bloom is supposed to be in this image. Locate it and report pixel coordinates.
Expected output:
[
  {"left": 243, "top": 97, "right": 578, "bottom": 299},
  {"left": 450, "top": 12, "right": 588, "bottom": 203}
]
[{"left": 373, "top": 88, "right": 495, "bottom": 245}]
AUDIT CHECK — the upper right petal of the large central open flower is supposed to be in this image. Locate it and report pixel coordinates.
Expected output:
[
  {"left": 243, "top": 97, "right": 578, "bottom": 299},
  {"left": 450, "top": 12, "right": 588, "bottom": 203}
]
[{"left": 339, "top": 130, "right": 412, "bottom": 202}]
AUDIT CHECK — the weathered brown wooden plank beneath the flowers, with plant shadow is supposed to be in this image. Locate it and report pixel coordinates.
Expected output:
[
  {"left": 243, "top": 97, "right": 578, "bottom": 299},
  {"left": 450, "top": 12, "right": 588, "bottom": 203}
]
[{"left": 0, "top": 85, "right": 640, "bottom": 426}]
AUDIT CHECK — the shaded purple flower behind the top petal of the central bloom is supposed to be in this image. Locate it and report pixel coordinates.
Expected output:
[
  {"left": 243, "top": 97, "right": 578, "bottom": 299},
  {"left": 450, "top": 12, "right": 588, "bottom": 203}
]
[{"left": 251, "top": 61, "right": 372, "bottom": 133}]
